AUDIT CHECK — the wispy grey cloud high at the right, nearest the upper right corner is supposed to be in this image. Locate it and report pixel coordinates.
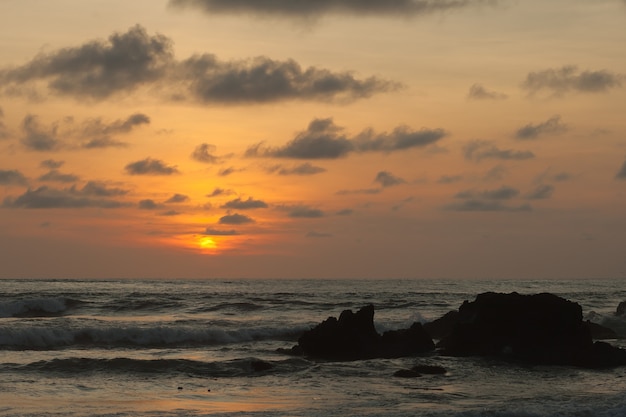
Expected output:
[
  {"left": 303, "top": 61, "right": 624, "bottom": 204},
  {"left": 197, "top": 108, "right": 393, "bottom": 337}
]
[{"left": 522, "top": 65, "right": 624, "bottom": 96}]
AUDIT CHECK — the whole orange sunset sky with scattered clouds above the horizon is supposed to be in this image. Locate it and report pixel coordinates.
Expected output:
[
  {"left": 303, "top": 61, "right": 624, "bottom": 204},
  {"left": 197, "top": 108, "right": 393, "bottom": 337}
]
[{"left": 0, "top": 0, "right": 626, "bottom": 279}]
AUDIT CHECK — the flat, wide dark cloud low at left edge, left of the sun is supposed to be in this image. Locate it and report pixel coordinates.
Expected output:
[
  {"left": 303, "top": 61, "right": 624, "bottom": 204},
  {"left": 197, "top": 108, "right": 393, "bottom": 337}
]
[{"left": 3, "top": 186, "right": 127, "bottom": 209}]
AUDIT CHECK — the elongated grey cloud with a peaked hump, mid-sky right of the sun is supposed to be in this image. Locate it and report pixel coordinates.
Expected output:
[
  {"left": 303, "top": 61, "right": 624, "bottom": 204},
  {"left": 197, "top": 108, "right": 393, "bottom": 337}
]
[{"left": 246, "top": 118, "right": 447, "bottom": 159}]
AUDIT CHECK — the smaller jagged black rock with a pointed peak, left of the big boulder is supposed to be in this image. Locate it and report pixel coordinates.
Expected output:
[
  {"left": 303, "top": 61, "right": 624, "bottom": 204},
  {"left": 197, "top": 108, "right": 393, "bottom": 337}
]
[{"left": 292, "top": 305, "right": 435, "bottom": 360}]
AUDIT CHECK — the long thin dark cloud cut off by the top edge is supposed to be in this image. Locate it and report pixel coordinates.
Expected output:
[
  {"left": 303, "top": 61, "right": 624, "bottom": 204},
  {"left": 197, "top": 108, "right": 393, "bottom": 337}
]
[{"left": 169, "top": 0, "right": 485, "bottom": 19}]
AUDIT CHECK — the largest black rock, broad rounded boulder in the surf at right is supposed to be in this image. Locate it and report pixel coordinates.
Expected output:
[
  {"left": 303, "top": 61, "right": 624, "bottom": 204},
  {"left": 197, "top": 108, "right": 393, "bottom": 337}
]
[{"left": 440, "top": 293, "right": 626, "bottom": 367}]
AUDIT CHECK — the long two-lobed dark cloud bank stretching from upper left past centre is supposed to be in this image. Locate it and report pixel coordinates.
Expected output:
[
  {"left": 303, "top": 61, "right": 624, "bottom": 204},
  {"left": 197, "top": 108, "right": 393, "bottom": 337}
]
[{"left": 0, "top": 25, "right": 402, "bottom": 104}]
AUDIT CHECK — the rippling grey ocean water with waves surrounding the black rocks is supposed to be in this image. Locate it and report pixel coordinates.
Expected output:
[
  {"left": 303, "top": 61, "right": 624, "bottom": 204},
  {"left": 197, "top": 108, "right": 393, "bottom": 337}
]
[{"left": 0, "top": 280, "right": 626, "bottom": 417}]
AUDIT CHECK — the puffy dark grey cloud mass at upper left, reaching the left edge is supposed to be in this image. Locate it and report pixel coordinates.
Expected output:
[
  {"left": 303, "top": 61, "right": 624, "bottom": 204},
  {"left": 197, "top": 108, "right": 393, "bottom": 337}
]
[{"left": 0, "top": 26, "right": 173, "bottom": 99}]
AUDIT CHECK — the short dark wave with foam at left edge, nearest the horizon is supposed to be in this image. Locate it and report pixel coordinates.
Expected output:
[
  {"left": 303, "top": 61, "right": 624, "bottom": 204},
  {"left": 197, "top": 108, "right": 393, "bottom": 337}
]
[{"left": 0, "top": 297, "right": 83, "bottom": 318}]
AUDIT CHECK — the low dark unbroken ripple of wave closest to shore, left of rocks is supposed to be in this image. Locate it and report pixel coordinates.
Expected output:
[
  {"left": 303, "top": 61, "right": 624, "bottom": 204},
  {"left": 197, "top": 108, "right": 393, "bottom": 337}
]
[{"left": 8, "top": 357, "right": 312, "bottom": 377}]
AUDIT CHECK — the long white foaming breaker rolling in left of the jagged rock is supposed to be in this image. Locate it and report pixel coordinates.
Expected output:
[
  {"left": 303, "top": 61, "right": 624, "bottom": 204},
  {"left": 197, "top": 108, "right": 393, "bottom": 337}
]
[{"left": 0, "top": 326, "right": 307, "bottom": 350}]
